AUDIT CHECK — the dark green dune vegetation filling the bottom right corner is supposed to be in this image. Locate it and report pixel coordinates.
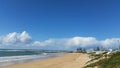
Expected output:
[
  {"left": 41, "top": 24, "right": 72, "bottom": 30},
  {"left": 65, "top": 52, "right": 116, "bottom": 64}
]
[{"left": 85, "top": 52, "right": 120, "bottom": 68}]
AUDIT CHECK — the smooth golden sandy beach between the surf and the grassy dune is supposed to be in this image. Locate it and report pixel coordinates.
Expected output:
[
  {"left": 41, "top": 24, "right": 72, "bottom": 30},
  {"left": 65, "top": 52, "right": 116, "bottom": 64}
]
[{"left": 3, "top": 53, "right": 90, "bottom": 68}]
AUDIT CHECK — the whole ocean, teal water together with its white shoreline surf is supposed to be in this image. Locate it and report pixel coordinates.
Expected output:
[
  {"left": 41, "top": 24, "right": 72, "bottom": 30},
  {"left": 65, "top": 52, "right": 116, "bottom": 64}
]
[{"left": 0, "top": 50, "right": 62, "bottom": 67}]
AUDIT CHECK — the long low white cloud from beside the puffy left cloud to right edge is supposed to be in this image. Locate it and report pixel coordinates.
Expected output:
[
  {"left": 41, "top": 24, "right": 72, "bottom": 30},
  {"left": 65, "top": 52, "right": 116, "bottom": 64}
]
[{"left": 32, "top": 37, "right": 120, "bottom": 48}]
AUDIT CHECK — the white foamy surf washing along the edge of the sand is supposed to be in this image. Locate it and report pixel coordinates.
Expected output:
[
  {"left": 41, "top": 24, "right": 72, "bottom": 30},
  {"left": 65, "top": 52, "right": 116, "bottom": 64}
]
[{"left": 0, "top": 53, "right": 62, "bottom": 66}]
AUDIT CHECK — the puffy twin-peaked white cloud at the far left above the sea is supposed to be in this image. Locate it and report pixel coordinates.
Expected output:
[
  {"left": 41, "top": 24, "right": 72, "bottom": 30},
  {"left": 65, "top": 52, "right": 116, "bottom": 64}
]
[{"left": 0, "top": 31, "right": 32, "bottom": 45}]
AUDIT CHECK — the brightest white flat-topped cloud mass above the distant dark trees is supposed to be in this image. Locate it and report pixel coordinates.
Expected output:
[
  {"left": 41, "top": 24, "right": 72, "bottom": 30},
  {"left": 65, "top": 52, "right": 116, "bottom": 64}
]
[{"left": 66, "top": 37, "right": 98, "bottom": 47}]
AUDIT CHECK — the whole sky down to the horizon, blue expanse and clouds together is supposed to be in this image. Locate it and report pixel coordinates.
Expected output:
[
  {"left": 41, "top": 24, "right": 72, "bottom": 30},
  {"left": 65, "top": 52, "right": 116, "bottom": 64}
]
[{"left": 0, "top": 0, "right": 120, "bottom": 49}]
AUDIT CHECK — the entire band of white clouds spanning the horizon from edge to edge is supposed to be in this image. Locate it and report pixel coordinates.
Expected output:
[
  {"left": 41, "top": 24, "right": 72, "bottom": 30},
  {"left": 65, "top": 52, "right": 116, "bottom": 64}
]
[{"left": 0, "top": 31, "right": 120, "bottom": 50}]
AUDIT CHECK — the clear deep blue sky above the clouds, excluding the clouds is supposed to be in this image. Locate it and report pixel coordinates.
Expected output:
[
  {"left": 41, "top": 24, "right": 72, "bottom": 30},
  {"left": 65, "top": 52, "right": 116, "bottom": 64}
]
[{"left": 0, "top": 0, "right": 120, "bottom": 49}]
